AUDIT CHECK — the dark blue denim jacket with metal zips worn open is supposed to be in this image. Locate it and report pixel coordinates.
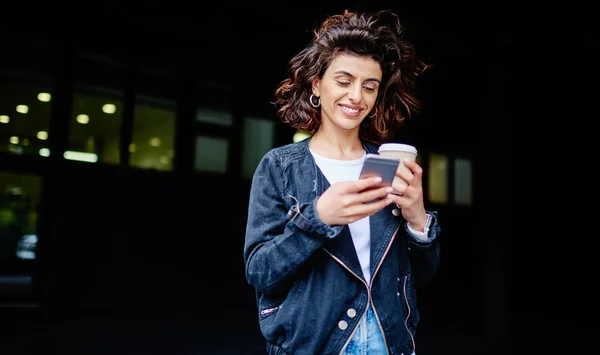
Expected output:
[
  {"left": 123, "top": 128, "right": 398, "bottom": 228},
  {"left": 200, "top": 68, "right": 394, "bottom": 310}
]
[{"left": 244, "top": 138, "right": 440, "bottom": 355}]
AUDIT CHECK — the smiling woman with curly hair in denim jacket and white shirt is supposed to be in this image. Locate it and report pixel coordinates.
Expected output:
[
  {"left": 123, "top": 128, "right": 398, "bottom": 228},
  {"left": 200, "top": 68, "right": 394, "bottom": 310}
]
[{"left": 244, "top": 11, "right": 440, "bottom": 355}]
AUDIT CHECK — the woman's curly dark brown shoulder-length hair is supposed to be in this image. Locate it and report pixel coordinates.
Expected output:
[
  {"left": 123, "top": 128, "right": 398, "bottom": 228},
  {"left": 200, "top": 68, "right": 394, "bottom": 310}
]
[{"left": 274, "top": 10, "right": 429, "bottom": 143}]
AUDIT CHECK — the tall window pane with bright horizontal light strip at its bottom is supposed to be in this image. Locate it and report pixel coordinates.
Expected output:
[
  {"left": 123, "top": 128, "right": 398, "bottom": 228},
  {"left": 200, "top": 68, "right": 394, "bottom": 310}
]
[{"left": 64, "top": 53, "right": 126, "bottom": 165}]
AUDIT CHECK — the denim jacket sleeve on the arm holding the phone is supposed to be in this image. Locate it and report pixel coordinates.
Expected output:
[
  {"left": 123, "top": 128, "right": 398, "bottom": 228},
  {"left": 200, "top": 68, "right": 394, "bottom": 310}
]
[{"left": 244, "top": 154, "right": 342, "bottom": 292}]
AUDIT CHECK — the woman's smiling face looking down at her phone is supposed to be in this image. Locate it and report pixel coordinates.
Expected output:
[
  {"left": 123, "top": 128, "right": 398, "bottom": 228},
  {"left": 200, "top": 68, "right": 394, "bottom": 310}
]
[{"left": 312, "top": 53, "right": 382, "bottom": 133}]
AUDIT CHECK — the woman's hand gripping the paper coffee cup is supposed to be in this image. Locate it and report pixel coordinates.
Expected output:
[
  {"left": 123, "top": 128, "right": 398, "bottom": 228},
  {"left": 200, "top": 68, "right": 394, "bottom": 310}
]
[{"left": 388, "top": 160, "right": 427, "bottom": 231}]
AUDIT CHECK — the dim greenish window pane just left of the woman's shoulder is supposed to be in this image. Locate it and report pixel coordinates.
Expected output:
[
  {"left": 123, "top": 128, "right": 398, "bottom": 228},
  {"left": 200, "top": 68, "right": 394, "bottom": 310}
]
[{"left": 242, "top": 117, "right": 275, "bottom": 179}]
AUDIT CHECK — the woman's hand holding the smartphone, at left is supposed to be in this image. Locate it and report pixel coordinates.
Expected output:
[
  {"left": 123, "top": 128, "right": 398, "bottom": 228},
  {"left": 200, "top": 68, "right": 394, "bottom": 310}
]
[{"left": 316, "top": 177, "right": 393, "bottom": 226}]
